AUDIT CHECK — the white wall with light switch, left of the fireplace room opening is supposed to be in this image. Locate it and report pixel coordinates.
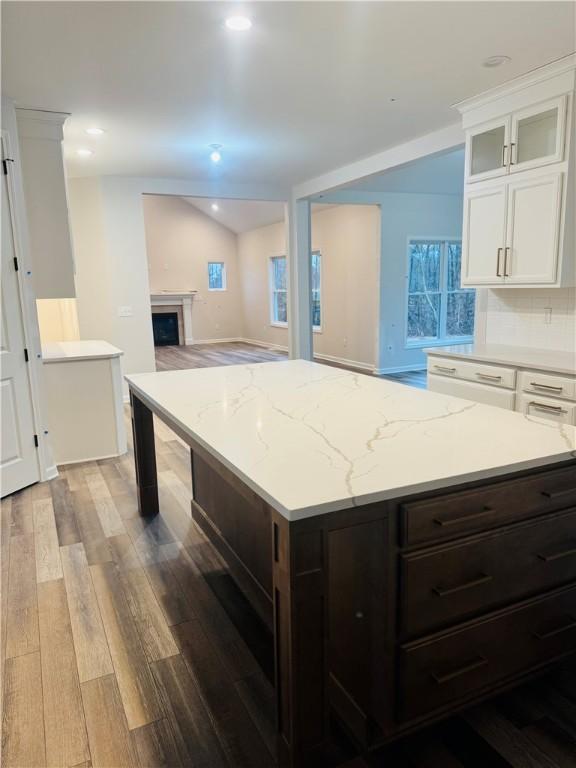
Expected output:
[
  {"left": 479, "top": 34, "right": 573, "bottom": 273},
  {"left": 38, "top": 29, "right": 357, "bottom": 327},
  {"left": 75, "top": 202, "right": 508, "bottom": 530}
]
[{"left": 68, "top": 176, "right": 286, "bottom": 384}]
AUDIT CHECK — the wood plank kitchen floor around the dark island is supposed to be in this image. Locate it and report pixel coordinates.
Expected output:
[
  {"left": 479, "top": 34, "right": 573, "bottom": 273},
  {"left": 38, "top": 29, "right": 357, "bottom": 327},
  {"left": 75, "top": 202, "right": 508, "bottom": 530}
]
[{"left": 0, "top": 380, "right": 576, "bottom": 768}]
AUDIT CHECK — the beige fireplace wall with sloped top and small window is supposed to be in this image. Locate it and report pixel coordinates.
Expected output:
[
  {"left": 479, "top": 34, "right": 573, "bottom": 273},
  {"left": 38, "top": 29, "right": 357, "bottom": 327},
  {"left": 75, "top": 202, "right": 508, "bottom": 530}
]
[{"left": 143, "top": 195, "right": 243, "bottom": 343}]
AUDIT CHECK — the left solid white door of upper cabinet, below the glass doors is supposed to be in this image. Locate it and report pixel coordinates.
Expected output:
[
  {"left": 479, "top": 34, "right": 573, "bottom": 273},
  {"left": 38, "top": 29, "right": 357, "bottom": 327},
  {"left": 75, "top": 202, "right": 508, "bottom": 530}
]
[{"left": 462, "top": 184, "right": 506, "bottom": 285}]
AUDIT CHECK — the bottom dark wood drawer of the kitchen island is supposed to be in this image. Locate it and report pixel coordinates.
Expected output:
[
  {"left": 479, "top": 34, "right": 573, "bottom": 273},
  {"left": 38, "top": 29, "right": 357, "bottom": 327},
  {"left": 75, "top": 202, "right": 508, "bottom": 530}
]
[{"left": 398, "top": 587, "right": 576, "bottom": 721}]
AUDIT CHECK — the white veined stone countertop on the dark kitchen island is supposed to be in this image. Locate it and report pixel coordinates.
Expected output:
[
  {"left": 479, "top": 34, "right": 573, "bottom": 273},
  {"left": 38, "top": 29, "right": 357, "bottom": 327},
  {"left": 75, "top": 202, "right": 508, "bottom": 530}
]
[{"left": 126, "top": 360, "right": 576, "bottom": 520}]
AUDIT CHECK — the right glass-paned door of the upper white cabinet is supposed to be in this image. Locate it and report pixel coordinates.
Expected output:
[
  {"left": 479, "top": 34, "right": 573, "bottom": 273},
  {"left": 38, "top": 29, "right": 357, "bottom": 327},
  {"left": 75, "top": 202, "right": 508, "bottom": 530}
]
[{"left": 510, "top": 96, "right": 566, "bottom": 172}]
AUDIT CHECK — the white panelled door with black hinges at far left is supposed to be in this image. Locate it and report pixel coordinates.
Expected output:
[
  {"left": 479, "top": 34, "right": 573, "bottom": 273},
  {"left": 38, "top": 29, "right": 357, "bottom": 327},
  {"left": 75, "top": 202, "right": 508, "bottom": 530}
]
[{"left": 0, "top": 141, "right": 40, "bottom": 496}]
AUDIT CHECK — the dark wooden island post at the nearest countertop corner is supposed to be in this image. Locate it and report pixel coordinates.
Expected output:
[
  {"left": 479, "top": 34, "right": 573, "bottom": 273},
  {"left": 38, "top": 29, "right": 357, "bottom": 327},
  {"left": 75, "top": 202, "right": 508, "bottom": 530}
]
[{"left": 272, "top": 514, "right": 328, "bottom": 768}]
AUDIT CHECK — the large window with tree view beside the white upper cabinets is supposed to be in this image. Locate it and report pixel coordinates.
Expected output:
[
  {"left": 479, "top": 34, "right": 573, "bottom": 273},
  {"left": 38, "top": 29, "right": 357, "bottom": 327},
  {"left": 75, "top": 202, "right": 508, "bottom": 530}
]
[{"left": 407, "top": 240, "right": 476, "bottom": 346}]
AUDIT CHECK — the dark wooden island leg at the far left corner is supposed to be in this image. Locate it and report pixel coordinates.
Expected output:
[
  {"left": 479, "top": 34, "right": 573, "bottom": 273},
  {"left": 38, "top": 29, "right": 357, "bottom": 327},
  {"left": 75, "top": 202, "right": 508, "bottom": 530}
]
[{"left": 130, "top": 392, "right": 159, "bottom": 517}]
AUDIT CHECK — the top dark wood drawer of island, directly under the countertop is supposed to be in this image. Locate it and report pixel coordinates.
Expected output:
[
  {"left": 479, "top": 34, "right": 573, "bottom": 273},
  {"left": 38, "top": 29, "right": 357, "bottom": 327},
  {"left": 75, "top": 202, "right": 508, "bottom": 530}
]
[{"left": 400, "top": 463, "right": 576, "bottom": 546}]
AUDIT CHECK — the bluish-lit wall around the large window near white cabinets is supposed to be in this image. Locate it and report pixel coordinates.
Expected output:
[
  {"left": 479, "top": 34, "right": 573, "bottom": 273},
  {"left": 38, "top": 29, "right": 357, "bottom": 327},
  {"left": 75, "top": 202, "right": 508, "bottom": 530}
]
[{"left": 379, "top": 194, "right": 462, "bottom": 372}]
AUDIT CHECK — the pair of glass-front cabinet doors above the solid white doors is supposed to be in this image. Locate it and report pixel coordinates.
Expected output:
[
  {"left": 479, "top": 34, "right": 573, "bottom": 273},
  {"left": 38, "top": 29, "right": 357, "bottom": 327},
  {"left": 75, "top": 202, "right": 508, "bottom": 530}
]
[{"left": 466, "top": 96, "right": 566, "bottom": 182}]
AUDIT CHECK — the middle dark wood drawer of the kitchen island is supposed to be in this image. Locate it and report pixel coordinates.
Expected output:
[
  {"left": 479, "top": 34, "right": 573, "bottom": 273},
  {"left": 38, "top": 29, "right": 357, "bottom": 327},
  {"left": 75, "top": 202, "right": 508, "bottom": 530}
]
[{"left": 400, "top": 508, "right": 576, "bottom": 637}]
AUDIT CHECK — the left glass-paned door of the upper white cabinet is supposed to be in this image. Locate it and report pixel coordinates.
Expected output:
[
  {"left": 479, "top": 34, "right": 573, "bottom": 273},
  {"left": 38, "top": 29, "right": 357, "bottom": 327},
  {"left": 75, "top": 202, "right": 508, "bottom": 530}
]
[{"left": 466, "top": 118, "right": 510, "bottom": 181}]
